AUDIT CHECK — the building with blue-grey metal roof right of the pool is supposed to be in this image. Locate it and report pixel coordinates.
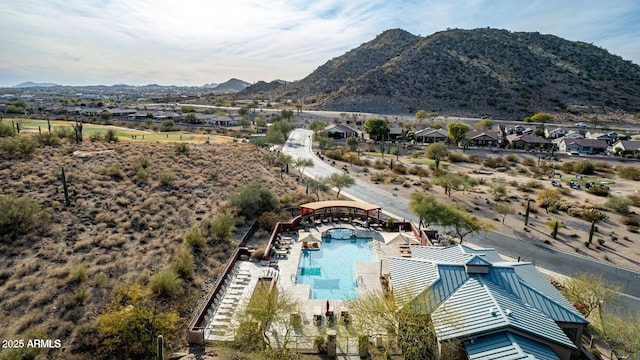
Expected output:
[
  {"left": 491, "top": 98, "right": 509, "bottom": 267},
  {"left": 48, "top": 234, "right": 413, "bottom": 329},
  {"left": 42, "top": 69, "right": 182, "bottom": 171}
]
[{"left": 389, "top": 245, "right": 588, "bottom": 360}]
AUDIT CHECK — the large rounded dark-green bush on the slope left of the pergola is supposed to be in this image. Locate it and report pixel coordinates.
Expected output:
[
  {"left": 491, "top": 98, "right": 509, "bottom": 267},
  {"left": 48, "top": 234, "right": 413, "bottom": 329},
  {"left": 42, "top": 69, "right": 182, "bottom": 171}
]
[{"left": 228, "top": 181, "right": 279, "bottom": 218}]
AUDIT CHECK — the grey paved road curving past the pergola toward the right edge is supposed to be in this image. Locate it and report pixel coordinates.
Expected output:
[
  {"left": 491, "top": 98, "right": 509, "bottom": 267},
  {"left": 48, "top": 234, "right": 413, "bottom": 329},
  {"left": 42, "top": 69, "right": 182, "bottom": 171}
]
[{"left": 282, "top": 129, "right": 640, "bottom": 309}]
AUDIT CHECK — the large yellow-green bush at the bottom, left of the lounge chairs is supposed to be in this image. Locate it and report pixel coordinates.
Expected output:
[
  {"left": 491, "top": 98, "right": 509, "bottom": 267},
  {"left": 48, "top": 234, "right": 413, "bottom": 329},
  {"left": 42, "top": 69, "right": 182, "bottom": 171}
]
[{"left": 95, "top": 284, "right": 179, "bottom": 359}]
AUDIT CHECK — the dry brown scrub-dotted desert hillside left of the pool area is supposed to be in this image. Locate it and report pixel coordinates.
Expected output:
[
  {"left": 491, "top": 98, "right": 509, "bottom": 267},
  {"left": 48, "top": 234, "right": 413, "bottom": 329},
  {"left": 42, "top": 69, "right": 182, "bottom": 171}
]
[{"left": 0, "top": 135, "right": 303, "bottom": 359}]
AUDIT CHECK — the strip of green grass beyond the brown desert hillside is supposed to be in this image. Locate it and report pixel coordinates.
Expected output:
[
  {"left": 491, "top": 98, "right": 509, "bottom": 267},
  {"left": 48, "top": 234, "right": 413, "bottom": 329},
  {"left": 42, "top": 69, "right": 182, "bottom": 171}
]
[{"left": 12, "top": 119, "right": 232, "bottom": 143}]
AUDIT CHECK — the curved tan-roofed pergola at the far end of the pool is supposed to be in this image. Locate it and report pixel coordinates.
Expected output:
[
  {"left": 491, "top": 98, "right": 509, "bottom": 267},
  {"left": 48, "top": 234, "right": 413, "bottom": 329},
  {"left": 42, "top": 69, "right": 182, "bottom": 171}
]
[{"left": 300, "top": 200, "right": 382, "bottom": 222}]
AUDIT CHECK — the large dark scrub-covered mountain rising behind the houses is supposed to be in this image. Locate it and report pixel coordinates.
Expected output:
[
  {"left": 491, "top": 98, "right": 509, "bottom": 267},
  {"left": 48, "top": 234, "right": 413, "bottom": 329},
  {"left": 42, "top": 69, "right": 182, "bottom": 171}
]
[{"left": 240, "top": 28, "right": 640, "bottom": 120}]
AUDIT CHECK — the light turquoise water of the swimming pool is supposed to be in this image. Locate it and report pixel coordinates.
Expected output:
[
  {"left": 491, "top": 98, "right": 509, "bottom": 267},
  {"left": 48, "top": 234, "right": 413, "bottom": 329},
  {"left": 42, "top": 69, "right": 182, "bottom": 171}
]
[{"left": 296, "top": 238, "right": 377, "bottom": 300}]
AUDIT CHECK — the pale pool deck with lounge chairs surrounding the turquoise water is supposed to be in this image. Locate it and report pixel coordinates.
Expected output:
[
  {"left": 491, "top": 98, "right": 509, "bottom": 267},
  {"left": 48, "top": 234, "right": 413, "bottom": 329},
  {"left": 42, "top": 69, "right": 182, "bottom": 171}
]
[{"left": 205, "top": 223, "right": 418, "bottom": 349}]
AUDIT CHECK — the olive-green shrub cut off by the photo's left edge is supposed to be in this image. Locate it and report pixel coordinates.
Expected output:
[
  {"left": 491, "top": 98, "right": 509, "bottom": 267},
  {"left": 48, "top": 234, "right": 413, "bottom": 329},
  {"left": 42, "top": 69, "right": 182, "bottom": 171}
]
[{"left": 0, "top": 195, "right": 51, "bottom": 235}]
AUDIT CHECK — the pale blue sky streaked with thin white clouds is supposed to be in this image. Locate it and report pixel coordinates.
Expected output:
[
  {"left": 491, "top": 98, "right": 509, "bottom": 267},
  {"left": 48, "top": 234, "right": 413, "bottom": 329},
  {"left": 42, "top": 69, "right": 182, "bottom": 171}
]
[{"left": 0, "top": 0, "right": 640, "bottom": 87}]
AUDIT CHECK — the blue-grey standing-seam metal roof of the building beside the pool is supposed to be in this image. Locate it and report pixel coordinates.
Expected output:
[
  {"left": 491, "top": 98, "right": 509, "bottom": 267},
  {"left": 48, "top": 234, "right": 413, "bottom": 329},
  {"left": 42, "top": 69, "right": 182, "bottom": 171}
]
[{"left": 389, "top": 245, "right": 588, "bottom": 349}]
